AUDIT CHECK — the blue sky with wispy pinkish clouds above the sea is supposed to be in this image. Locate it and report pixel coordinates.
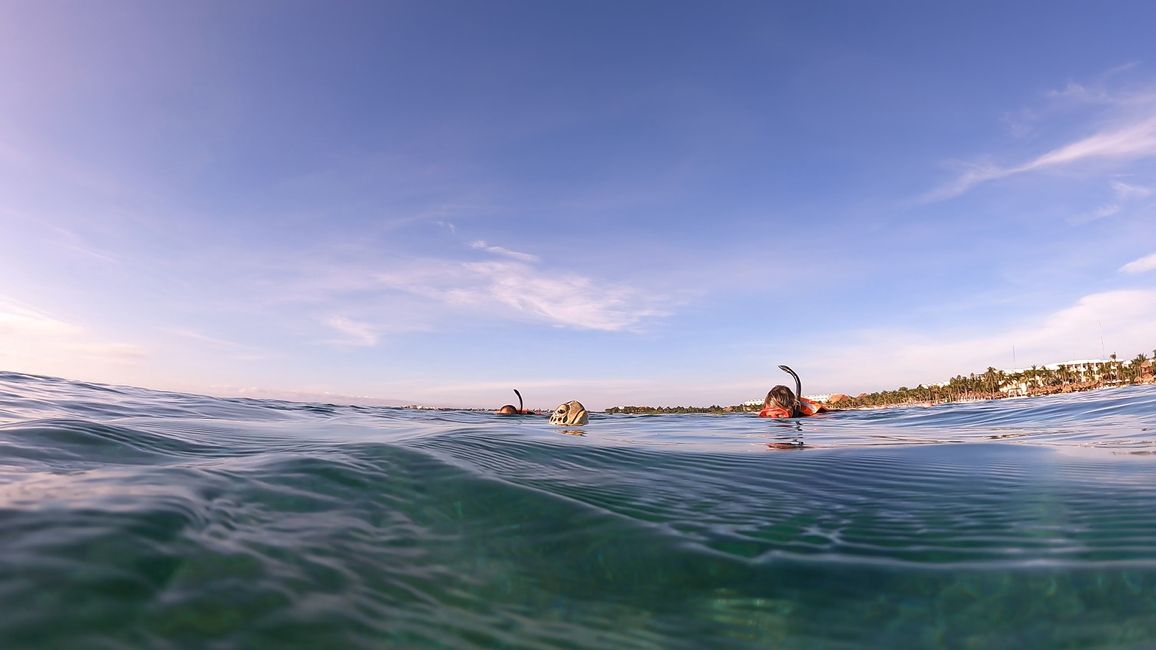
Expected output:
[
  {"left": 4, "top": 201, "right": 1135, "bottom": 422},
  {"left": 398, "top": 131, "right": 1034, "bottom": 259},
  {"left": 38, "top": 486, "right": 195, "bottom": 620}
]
[{"left": 0, "top": 0, "right": 1156, "bottom": 409}]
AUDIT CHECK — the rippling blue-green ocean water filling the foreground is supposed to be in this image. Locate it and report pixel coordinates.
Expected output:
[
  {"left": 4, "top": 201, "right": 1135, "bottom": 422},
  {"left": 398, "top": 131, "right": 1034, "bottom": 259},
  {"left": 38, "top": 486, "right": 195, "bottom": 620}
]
[{"left": 0, "top": 372, "right": 1156, "bottom": 649}]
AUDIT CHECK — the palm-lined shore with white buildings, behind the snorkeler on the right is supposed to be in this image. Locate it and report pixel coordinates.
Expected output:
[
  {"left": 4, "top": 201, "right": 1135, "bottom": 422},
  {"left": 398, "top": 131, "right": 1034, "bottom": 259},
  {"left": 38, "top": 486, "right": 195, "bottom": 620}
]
[{"left": 606, "top": 349, "right": 1156, "bottom": 414}]
